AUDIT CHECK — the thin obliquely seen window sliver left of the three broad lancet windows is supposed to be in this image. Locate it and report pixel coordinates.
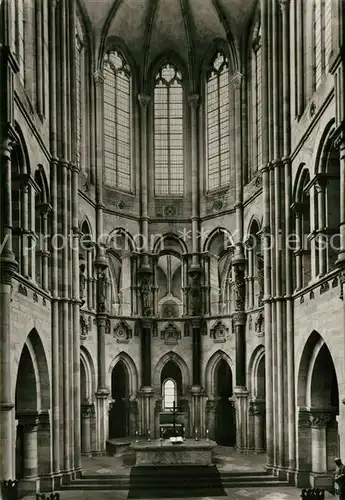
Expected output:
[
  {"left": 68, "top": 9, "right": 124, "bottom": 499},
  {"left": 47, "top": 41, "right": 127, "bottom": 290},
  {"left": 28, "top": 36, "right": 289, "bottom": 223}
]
[{"left": 75, "top": 20, "right": 85, "bottom": 168}]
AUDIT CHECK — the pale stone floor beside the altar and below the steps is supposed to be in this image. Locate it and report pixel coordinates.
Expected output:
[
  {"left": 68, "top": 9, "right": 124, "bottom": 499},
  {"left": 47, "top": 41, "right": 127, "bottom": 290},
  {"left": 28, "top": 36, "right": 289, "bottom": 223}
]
[{"left": 24, "top": 446, "right": 335, "bottom": 500}]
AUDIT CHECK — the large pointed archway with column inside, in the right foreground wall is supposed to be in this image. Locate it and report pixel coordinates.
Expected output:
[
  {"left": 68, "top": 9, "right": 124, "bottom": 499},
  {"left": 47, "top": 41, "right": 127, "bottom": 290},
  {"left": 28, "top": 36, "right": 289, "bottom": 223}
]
[{"left": 297, "top": 332, "right": 340, "bottom": 488}]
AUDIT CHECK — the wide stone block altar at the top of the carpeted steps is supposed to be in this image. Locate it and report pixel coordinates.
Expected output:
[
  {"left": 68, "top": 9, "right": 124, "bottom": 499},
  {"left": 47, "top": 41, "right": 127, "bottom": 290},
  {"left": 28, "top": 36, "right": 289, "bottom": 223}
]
[{"left": 130, "top": 439, "right": 217, "bottom": 467}]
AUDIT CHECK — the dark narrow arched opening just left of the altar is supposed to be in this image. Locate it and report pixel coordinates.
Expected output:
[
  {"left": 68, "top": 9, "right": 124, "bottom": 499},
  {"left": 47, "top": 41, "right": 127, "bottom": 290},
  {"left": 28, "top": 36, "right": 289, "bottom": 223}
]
[{"left": 109, "top": 359, "right": 130, "bottom": 439}]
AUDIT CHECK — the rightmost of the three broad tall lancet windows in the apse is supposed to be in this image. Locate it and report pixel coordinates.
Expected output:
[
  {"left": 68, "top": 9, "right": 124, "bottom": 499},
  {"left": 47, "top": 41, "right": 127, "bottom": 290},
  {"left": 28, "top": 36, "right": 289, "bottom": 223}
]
[{"left": 206, "top": 53, "right": 230, "bottom": 191}]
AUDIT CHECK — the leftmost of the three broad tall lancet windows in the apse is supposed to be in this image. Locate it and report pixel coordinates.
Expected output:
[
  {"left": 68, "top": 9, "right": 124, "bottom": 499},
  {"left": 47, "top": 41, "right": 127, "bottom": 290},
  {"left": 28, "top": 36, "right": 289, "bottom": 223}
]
[{"left": 104, "top": 51, "right": 132, "bottom": 191}]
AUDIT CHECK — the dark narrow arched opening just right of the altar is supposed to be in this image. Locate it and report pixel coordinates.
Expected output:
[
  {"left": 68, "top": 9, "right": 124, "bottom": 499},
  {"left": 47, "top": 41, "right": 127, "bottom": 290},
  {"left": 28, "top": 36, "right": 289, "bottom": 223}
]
[{"left": 214, "top": 358, "right": 236, "bottom": 446}]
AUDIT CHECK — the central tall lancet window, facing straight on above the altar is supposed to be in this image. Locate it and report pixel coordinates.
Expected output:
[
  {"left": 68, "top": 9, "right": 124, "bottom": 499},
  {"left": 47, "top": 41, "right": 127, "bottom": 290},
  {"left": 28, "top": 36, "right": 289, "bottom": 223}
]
[{"left": 154, "top": 63, "right": 184, "bottom": 196}]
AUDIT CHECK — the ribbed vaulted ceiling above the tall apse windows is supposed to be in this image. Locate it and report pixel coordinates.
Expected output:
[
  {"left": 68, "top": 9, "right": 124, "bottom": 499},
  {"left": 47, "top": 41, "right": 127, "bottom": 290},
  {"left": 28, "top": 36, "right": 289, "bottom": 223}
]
[{"left": 80, "top": 0, "right": 257, "bottom": 83}]
